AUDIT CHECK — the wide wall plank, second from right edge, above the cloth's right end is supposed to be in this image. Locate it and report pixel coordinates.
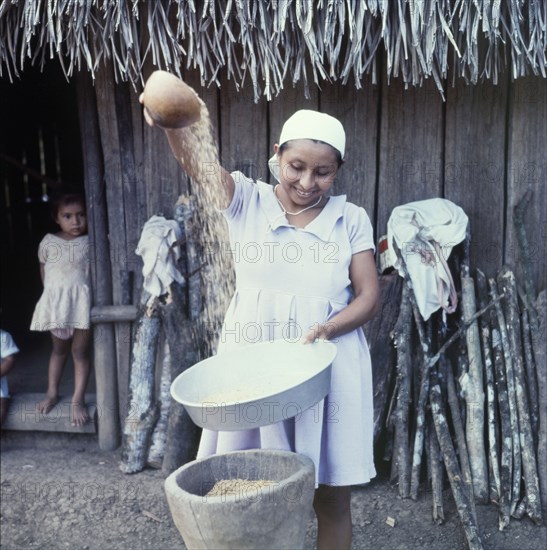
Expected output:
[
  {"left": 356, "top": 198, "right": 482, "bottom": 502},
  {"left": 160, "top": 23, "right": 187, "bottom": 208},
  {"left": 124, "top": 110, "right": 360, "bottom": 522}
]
[{"left": 444, "top": 75, "right": 508, "bottom": 276}]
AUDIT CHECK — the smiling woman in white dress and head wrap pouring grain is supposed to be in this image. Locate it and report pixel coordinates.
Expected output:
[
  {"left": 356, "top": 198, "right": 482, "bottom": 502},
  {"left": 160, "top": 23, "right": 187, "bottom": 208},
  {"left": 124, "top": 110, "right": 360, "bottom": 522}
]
[{"left": 141, "top": 96, "right": 379, "bottom": 548}]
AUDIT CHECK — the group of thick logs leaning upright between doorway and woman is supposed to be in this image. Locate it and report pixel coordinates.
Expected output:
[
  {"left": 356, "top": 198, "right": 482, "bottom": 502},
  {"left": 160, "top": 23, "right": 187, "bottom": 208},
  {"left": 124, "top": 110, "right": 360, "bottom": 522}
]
[{"left": 119, "top": 196, "right": 202, "bottom": 474}]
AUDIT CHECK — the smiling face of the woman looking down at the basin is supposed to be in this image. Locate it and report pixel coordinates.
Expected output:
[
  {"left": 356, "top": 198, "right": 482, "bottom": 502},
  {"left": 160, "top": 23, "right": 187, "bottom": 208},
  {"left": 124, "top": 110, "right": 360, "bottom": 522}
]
[{"left": 274, "top": 139, "right": 340, "bottom": 209}]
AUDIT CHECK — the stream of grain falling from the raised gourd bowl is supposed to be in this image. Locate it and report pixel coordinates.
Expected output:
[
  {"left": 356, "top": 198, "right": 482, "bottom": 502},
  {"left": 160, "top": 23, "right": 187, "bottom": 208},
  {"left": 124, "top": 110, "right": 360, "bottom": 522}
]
[{"left": 174, "top": 98, "right": 235, "bottom": 355}]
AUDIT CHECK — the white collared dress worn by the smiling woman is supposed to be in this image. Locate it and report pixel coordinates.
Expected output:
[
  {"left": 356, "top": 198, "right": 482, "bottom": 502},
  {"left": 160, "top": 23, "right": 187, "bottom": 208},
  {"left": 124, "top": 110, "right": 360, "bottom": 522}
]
[{"left": 198, "top": 172, "right": 376, "bottom": 486}]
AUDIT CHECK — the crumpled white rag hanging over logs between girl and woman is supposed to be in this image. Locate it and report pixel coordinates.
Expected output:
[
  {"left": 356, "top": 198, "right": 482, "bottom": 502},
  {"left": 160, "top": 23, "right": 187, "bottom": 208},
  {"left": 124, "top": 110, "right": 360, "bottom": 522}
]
[{"left": 135, "top": 216, "right": 184, "bottom": 296}]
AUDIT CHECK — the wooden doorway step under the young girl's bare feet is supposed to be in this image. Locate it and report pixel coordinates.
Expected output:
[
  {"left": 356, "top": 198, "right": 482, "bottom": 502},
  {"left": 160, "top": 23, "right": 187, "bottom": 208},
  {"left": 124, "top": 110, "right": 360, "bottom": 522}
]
[{"left": 2, "top": 393, "right": 97, "bottom": 433}]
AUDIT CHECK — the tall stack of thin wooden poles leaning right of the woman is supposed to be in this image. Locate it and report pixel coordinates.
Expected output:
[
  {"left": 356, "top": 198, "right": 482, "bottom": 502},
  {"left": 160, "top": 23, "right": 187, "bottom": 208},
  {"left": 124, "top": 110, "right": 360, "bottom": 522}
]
[{"left": 384, "top": 201, "right": 547, "bottom": 549}]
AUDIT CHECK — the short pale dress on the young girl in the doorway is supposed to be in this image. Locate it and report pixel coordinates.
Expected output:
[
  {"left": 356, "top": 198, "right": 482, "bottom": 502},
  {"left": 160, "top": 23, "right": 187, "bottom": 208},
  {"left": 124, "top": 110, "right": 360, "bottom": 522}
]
[{"left": 30, "top": 233, "right": 91, "bottom": 331}]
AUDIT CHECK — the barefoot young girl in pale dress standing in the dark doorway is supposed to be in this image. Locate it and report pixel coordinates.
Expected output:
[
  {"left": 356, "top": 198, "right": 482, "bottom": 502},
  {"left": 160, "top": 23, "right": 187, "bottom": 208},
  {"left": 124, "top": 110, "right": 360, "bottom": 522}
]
[{"left": 30, "top": 190, "right": 91, "bottom": 426}]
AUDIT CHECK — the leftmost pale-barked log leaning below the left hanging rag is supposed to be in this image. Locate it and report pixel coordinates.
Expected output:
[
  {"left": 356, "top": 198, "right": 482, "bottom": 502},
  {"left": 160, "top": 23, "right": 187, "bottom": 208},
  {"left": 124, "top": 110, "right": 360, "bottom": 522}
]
[{"left": 120, "top": 297, "right": 161, "bottom": 474}]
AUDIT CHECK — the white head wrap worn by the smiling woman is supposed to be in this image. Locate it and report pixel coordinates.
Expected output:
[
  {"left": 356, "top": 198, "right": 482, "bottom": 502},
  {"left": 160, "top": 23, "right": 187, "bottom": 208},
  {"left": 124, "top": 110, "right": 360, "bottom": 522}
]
[{"left": 268, "top": 109, "right": 346, "bottom": 181}]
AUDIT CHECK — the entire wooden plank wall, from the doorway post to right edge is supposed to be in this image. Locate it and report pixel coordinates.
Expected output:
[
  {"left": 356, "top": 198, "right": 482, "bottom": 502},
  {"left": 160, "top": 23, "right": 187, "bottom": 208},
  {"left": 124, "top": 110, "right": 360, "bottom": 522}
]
[{"left": 88, "top": 67, "right": 547, "bottom": 436}]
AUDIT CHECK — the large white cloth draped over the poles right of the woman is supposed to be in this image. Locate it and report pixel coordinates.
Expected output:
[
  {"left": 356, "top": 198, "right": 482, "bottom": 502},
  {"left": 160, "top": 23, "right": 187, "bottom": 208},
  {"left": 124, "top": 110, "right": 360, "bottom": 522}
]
[{"left": 387, "top": 199, "right": 468, "bottom": 321}]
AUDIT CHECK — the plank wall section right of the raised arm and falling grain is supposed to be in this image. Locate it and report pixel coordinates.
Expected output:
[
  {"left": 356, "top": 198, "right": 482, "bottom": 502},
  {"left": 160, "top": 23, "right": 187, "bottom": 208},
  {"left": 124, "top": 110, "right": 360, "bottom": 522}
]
[{"left": 148, "top": 72, "right": 547, "bottom": 289}]
